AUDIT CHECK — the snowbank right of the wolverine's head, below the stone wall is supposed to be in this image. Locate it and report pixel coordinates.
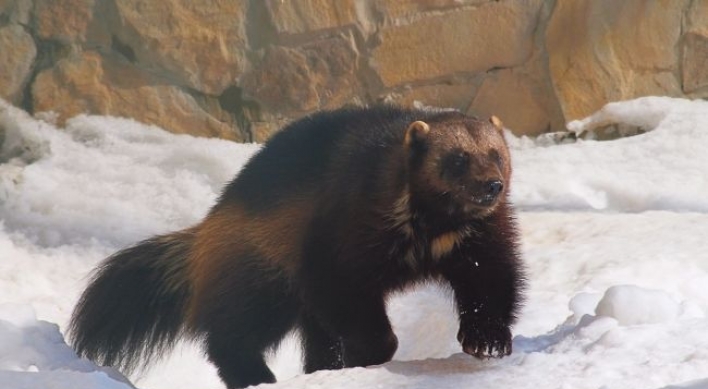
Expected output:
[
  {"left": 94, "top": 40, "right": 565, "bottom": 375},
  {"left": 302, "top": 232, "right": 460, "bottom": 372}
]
[{"left": 513, "top": 97, "right": 708, "bottom": 212}]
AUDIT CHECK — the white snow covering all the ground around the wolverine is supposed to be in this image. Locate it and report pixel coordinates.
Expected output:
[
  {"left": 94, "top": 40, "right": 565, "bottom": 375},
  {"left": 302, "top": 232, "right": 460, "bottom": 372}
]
[{"left": 0, "top": 94, "right": 708, "bottom": 389}]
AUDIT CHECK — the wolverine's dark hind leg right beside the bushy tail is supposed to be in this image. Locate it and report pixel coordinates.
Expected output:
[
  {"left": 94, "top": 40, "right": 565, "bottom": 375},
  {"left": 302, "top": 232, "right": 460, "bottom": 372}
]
[{"left": 192, "top": 257, "right": 298, "bottom": 389}]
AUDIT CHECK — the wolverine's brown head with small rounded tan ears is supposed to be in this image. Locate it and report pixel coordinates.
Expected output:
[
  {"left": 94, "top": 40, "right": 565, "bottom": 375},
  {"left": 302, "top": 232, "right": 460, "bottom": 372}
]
[{"left": 404, "top": 113, "right": 511, "bottom": 218}]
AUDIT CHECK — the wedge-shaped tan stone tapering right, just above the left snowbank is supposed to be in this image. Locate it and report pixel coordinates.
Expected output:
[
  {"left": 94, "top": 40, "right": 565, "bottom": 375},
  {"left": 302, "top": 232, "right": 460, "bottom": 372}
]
[{"left": 32, "top": 52, "right": 243, "bottom": 140}]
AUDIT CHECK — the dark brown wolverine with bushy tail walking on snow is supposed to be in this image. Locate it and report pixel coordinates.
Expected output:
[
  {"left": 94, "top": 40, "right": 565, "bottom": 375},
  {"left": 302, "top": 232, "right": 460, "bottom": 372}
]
[{"left": 69, "top": 106, "right": 524, "bottom": 388}]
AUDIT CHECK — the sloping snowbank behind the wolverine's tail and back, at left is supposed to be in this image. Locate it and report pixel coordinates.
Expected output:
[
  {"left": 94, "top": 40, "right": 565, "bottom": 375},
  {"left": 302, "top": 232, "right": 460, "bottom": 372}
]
[{"left": 0, "top": 100, "right": 258, "bottom": 246}]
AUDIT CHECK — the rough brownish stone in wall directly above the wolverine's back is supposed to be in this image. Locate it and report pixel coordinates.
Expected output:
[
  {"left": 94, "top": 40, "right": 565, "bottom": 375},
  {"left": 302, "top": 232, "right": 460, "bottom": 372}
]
[{"left": 241, "top": 36, "right": 359, "bottom": 114}]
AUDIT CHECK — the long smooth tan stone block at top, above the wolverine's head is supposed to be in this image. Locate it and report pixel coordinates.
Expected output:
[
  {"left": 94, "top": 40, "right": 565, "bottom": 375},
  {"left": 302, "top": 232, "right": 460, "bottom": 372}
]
[{"left": 371, "top": 0, "right": 541, "bottom": 87}]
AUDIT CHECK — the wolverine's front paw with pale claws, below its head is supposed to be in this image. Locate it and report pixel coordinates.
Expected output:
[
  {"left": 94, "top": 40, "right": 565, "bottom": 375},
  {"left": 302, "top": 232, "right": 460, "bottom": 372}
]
[{"left": 457, "top": 322, "right": 511, "bottom": 359}]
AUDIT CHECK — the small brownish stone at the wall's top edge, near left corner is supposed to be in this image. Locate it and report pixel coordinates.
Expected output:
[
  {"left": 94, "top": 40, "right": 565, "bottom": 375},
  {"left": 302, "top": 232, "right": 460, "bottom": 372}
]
[{"left": 34, "top": 0, "right": 95, "bottom": 42}]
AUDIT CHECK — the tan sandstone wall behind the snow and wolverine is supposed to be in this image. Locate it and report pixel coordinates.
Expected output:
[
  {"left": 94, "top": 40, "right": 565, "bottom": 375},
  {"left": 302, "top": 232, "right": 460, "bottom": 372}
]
[{"left": 0, "top": 0, "right": 708, "bottom": 141}]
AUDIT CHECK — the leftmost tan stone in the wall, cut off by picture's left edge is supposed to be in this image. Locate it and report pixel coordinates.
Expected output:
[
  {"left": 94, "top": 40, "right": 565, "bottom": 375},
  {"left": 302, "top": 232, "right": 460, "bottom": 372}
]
[{"left": 0, "top": 25, "right": 37, "bottom": 104}]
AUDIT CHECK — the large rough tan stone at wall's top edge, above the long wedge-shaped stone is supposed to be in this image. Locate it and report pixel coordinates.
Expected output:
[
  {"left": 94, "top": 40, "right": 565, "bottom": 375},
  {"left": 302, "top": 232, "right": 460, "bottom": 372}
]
[{"left": 110, "top": 0, "right": 246, "bottom": 95}]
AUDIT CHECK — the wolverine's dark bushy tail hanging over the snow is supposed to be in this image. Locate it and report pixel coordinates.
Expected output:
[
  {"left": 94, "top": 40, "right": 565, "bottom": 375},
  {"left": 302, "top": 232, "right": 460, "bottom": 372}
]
[{"left": 69, "top": 230, "right": 194, "bottom": 374}]
